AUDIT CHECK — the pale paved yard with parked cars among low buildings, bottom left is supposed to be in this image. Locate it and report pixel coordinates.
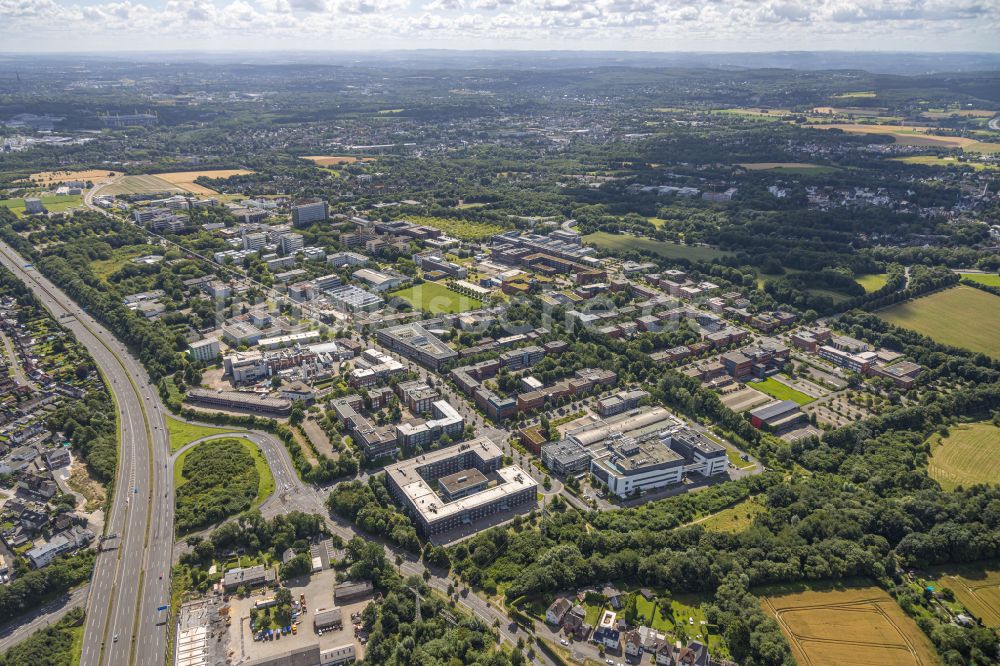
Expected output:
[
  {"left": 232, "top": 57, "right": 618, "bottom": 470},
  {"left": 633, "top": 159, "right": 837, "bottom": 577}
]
[{"left": 229, "top": 569, "right": 371, "bottom": 664}]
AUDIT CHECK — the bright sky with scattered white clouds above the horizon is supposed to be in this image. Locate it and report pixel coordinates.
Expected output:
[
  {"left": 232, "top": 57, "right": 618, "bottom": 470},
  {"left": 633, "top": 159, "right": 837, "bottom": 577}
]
[{"left": 0, "top": 0, "right": 1000, "bottom": 51}]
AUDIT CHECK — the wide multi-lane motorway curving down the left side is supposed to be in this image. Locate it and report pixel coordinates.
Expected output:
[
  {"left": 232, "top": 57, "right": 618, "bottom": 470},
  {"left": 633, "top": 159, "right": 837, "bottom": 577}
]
[{"left": 0, "top": 243, "right": 174, "bottom": 666}]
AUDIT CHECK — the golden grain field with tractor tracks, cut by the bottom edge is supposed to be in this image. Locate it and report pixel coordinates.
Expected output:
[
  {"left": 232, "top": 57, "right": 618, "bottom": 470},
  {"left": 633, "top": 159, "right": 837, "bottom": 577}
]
[{"left": 761, "top": 586, "right": 940, "bottom": 666}]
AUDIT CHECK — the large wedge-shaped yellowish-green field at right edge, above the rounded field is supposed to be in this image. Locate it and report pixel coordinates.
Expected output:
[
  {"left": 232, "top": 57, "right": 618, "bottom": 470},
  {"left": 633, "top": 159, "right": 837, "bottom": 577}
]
[{"left": 876, "top": 285, "right": 1000, "bottom": 358}]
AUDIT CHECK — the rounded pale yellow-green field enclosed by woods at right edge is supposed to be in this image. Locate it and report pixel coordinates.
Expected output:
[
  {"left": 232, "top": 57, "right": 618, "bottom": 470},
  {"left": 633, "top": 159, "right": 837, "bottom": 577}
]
[{"left": 927, "top": 421, "right": 1000, "bottom": 490}]
